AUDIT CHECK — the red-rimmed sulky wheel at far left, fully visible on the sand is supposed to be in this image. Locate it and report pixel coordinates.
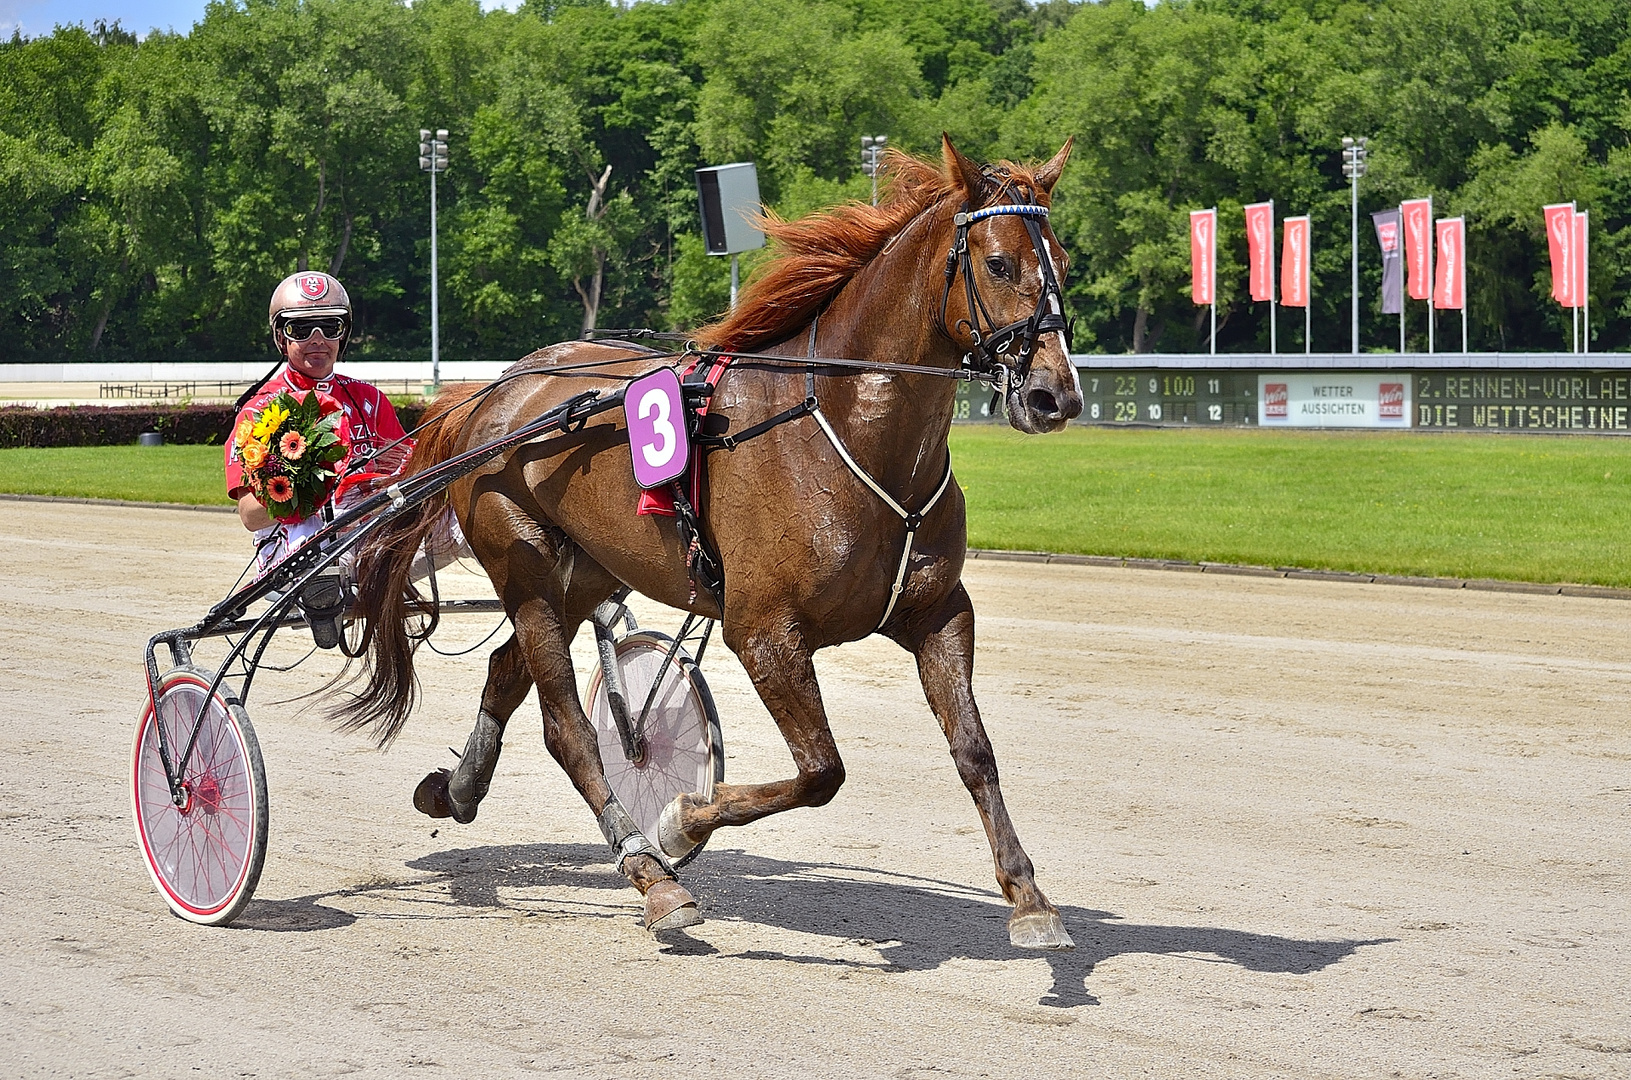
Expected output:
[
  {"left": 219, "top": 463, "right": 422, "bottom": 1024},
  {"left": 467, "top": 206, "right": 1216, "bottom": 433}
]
[{"left": 130, "top": 667, "right": 266, "bottom": 927}]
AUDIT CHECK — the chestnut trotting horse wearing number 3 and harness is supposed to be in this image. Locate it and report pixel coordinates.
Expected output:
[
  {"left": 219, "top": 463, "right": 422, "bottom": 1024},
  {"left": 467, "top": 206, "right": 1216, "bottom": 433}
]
[{"left": 338, "top": 139, "right": 1081, "bottom": 948}]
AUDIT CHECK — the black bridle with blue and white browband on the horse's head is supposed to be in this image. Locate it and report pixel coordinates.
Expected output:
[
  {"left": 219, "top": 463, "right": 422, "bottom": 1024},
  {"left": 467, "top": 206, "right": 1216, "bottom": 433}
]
[{"left": 939, "top": 193, "right": 1072, "bottom": 395}]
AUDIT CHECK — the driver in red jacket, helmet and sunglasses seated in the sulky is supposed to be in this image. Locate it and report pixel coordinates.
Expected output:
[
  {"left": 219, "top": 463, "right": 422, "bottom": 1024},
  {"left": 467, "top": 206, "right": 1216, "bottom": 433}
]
[{"left": 227, "top": 271, "right": 411, "bottom": 644}]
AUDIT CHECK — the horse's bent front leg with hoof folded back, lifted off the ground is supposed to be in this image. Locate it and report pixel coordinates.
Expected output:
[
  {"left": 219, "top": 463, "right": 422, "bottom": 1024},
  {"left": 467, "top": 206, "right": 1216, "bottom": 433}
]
[{"left": 657, "top": 620, "right": 843, "bottom": 858}]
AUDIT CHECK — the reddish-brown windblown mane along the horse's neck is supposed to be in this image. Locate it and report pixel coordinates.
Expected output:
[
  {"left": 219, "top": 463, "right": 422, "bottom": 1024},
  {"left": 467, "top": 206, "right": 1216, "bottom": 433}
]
[{"left": 696, "top": 150, "right": 1036, "bottom": 352}]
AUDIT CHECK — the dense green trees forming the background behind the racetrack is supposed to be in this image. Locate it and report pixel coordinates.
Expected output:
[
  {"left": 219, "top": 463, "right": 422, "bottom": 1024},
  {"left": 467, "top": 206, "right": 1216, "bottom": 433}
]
[{"left": 9, "top": 0, "right": 1631, "bottom": 361}]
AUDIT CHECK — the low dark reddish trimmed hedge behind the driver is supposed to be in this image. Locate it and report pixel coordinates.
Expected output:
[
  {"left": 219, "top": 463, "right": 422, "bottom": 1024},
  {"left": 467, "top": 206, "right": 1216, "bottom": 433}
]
[{"left": 0, "top": 405, "right": 424, "bottom": 449}]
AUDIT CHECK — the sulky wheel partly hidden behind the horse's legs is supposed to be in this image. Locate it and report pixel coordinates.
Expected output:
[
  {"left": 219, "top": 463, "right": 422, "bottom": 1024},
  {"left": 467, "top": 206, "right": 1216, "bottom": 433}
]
[{"left": 589, "top": 630, "right": 724, "bottom": 866}]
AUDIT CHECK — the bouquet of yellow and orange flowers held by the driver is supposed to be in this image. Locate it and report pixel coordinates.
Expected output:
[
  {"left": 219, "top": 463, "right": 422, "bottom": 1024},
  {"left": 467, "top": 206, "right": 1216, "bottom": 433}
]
[{"left": 233, "top": 390, "right": 346, "bottom": 524}]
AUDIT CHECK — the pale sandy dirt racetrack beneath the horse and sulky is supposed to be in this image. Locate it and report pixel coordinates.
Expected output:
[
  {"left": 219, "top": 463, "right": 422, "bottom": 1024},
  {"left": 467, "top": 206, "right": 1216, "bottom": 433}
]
[{"left": 0, "top": 501, "right": 1631, "bottom": 1078}]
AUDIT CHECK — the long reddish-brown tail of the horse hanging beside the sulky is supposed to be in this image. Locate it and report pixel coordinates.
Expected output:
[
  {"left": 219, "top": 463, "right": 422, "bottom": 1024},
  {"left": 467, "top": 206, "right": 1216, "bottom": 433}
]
[{"left": 329, "top": 383, "right": 481, "bottom": 747}]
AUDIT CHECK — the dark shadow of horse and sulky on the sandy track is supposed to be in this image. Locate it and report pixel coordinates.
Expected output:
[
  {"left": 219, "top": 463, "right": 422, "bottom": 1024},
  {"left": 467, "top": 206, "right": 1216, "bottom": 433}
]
[{"left": 240, "top": 843, "right": 1393, "bottom": 1008}]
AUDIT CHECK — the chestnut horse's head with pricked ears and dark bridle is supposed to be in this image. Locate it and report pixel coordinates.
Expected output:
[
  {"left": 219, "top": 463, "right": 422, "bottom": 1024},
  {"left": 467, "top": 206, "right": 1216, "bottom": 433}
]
[{"left": 941, "top": 135, "right": 1081, "bottom": 434}]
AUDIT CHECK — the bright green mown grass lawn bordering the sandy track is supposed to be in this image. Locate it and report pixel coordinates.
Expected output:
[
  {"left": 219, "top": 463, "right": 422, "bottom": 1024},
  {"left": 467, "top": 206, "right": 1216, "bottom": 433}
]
[{"left": 0, "top": 426, "right": 1631, "bottom": 586}]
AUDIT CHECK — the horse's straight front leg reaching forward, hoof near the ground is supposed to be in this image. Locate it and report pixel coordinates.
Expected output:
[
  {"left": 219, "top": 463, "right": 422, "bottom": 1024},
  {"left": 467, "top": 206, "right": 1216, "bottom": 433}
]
[{"left": 894, "top": 582, "right": 1075, "bottom": 949}]
